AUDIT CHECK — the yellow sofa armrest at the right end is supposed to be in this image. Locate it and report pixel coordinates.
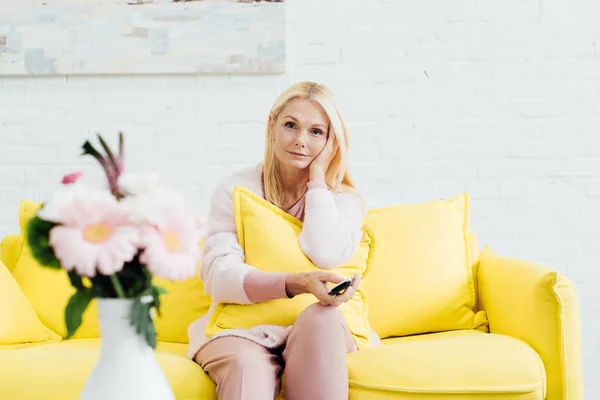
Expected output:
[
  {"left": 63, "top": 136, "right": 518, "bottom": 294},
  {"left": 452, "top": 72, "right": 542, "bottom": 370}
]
[{"left": 478, "top": 247, "right": 583, "bottom": 400}]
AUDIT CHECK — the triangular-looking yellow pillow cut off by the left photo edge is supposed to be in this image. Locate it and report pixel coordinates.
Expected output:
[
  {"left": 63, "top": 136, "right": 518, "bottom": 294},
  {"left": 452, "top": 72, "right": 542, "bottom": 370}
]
[{"left": 0, "top": 261, "right": 61, "bottom": 349}]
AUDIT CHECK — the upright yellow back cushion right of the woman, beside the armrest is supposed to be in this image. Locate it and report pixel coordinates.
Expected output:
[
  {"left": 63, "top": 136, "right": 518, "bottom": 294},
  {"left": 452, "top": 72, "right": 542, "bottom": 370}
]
[{"left": 365, "top": 194, "right": 487, "bottom": 338}]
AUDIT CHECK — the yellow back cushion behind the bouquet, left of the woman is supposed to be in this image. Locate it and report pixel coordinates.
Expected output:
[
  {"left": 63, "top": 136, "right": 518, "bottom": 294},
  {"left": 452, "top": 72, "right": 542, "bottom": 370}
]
[{"left": 13, "top": 200, "right": 210, "bottom": 343}]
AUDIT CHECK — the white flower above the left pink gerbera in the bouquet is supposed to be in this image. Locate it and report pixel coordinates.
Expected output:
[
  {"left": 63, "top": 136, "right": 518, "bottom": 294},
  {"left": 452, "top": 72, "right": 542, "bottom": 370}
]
[{"left": 37, "top": 181, "right": 117, "bottom": 224}]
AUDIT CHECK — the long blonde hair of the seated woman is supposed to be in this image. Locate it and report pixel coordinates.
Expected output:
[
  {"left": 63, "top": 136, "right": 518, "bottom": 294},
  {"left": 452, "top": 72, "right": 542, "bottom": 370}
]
[{"left": 263, "top": 82, "right": 355, "bottom": 207}]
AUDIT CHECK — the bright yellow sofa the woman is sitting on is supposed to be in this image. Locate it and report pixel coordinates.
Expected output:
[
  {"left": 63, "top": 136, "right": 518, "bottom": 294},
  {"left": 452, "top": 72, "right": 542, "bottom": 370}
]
[{"left": 0, "top": 195, "right": 583, "bottom": 400}]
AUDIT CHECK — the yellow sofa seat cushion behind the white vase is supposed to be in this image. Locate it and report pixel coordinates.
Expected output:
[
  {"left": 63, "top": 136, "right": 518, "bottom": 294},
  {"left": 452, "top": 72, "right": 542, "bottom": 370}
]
[{"left": 0, "top": 339, "right": 217, "bottom": 400}]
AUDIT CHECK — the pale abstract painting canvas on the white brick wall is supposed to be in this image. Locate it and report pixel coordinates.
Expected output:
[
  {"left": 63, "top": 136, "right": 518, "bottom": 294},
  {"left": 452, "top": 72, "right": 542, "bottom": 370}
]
[{"left": 0, "top": 0, "right": 285, "bottom": 75}]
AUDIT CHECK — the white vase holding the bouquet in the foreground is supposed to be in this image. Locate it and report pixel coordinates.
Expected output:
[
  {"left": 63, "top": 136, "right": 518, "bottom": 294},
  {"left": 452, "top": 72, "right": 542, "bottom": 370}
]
[{"left": 79, "top": 299, "right": 175, "bottom": 400}]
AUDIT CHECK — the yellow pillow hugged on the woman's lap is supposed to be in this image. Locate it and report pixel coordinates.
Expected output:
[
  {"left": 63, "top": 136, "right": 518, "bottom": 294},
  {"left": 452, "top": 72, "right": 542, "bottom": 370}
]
[{"left": 206, "top": 187, "right": 373, "bottom": 348}]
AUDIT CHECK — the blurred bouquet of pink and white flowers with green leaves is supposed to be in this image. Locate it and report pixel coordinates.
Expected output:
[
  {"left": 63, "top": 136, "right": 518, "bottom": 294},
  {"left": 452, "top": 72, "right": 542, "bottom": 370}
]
[{"left": 27, "top": 133, "right": 203, "bottom": 348}]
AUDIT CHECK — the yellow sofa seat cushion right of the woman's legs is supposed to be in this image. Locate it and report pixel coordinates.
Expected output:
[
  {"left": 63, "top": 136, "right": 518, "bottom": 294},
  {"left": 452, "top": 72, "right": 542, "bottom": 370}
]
[{"left": 348, "top": 330, "right": 545, "bottom": 400}]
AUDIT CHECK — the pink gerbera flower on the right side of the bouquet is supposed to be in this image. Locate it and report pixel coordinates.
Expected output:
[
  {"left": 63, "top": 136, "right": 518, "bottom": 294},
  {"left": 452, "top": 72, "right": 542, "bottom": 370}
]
[{"left": 140, "top": 211, "right": 201, "bottom": 281}]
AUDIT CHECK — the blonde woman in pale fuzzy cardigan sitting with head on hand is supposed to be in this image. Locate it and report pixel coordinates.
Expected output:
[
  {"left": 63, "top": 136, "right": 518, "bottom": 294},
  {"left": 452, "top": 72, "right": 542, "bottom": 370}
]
[{"left": 188, "top": 82, "right": 376, "bottom": 400}]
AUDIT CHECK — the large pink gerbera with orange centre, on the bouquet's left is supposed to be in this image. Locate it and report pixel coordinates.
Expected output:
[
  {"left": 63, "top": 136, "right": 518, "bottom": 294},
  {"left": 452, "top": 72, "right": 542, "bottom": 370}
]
[{"left": 50, "top": 201, "right": 140, "bottom": 277}]
